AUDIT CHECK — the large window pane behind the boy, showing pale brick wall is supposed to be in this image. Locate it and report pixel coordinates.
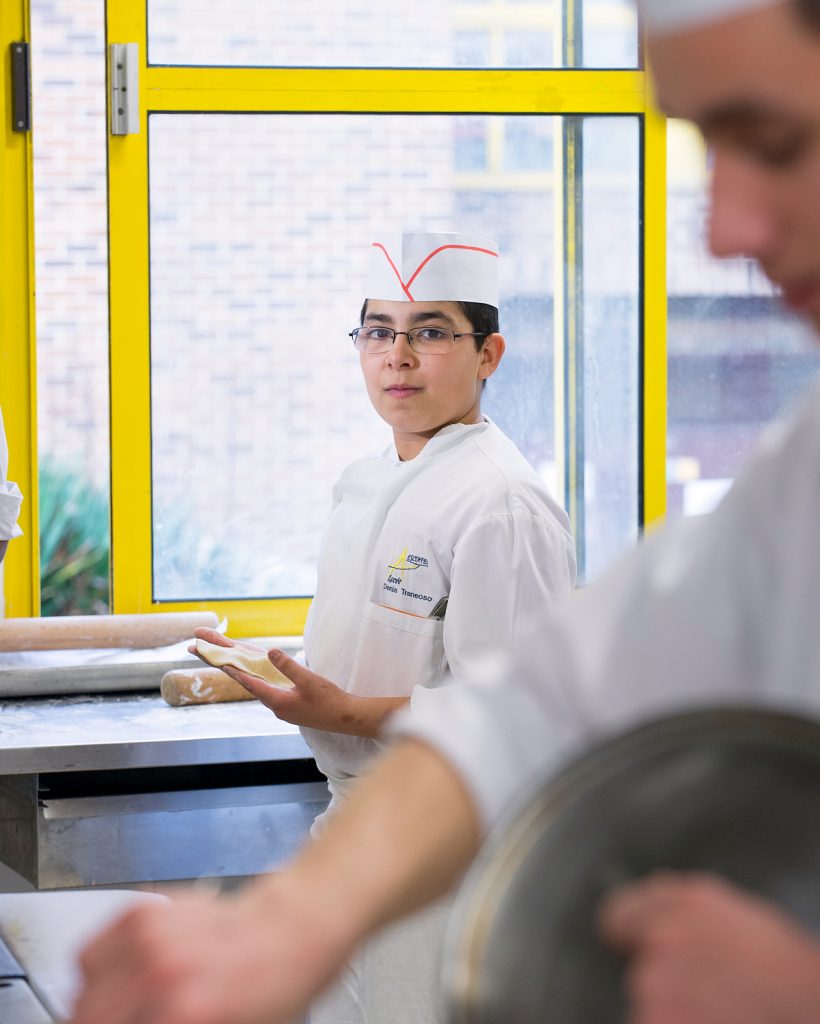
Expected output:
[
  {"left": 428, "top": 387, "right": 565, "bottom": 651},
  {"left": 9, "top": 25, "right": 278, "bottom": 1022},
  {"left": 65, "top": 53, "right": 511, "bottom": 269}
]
[{"left": 149, "top": 114, "right": 636, "bottom": 600}]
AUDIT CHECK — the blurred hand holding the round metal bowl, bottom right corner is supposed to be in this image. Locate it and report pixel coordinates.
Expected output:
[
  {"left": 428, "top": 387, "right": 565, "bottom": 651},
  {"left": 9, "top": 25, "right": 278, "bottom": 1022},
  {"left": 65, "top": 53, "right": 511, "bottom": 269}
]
[{"left": 599, "top": 872, "right": 820, "bottom": 1024}]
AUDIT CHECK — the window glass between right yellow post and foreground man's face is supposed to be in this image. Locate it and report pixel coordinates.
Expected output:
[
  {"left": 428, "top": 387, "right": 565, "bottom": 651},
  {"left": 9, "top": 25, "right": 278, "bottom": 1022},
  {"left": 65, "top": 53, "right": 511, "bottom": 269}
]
[{"left": 667, "top": 121, "right": 820, "bottom": 515}]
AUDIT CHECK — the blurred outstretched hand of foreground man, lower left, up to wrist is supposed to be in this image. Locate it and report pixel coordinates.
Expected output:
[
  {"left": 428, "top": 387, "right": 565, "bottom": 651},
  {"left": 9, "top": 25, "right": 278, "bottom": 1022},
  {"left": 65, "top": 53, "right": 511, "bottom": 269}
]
[{"left": 71, "top": 880, "right": 348, "bottom": 1024}]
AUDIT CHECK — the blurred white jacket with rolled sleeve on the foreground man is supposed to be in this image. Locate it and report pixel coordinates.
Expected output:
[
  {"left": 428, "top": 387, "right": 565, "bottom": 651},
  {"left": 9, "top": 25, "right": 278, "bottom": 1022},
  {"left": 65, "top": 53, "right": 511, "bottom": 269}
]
[{"left": 388, "top": 374, "right": 820, "bottom": 827}]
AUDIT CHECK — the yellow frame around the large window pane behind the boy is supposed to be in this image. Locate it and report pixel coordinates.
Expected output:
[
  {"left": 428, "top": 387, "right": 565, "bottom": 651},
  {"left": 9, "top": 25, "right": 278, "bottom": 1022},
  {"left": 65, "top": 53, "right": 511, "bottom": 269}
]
[{"left": 106, "top": 0, "right": 666, "bottom": 636}]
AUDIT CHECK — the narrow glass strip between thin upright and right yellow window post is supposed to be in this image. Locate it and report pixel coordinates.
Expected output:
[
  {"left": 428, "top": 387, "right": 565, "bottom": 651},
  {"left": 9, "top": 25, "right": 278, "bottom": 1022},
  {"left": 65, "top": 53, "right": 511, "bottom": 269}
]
[{"left": 582, "top": 118, "right": 640, "bottom": 581}]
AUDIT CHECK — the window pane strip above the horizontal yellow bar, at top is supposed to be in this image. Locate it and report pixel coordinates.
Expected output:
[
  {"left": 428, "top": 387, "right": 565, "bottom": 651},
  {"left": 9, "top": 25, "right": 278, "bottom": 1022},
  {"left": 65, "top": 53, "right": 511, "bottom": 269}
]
[{"left": 147, "top": 0, "right": 638, "bottom": 68}]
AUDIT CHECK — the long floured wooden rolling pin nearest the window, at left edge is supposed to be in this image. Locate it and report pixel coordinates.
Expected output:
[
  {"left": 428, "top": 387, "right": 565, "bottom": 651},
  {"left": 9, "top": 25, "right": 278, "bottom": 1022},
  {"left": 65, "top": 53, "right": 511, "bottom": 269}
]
[{"left": 0, "top": 611, "right": 219, "bottom": 651}]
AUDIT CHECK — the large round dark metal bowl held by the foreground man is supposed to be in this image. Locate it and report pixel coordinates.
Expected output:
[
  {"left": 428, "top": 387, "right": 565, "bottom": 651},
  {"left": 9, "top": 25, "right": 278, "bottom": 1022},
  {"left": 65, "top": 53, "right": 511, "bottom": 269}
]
[{"left": 445, "top": 709, "right": 820, "bottom": 1024}]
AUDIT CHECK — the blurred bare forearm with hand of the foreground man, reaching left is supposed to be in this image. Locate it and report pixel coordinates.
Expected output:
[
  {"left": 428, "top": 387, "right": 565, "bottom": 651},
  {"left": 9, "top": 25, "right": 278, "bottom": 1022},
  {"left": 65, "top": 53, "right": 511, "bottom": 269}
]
[{"left": 72, "top": 742, "right": 479, "bottom": 1024}]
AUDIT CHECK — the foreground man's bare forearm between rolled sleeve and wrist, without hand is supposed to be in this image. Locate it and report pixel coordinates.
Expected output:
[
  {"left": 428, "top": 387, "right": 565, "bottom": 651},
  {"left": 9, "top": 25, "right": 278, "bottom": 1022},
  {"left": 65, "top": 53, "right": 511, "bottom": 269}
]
[{"left": 259, "top": 741, "right": 480, "bottom": 948}]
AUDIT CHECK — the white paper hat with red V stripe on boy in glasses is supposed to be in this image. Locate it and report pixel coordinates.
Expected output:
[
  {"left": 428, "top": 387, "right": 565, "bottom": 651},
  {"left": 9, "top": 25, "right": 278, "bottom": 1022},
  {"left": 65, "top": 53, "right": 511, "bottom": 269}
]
[{"left": 365, "top": 231, "right": 499, "bottom": 307}]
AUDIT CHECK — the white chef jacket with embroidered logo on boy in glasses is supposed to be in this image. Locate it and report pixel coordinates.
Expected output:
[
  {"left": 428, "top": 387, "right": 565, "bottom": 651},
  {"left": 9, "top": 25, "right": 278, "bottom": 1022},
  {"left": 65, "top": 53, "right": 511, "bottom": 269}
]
[{"left": 302, "top": 419, "right": 575, "bottom": 796}]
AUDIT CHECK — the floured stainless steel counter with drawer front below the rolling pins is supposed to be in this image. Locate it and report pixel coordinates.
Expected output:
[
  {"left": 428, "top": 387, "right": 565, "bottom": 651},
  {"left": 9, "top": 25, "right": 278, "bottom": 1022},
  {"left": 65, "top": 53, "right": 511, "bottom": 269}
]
[{"left": 0, "top": 694, "right": 327, "bottom": 889}]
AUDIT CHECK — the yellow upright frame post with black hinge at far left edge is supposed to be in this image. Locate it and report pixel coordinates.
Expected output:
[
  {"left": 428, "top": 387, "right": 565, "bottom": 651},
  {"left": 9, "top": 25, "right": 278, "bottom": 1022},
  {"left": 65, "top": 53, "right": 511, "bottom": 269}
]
[{"left": 0, "top": 0, "right": 40, "bottom": 615}]
